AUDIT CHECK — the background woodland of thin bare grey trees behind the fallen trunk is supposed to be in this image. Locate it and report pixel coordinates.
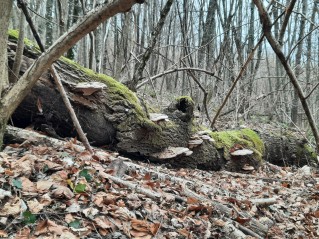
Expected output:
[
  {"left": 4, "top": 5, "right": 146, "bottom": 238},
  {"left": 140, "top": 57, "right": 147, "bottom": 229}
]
[{"left": 6, "top": 0, "right": 319, "bottom": 138}]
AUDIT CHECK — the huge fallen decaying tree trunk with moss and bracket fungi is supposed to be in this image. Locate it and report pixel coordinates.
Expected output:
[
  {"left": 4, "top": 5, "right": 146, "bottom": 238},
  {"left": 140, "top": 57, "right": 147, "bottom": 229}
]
[{"left": 6, "top": 35, "right": 316, "bottom": 171}]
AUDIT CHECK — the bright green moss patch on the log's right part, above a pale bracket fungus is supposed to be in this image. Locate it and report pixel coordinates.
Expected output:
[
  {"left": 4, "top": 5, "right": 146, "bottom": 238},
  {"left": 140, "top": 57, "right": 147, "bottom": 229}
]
[{"left": 210, "top": 129, "right": 265, "bottom": 160}]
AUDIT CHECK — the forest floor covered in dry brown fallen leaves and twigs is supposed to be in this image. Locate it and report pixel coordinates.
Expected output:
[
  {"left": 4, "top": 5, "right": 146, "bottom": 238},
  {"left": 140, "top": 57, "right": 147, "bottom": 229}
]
[{"left": 0, "top": 129, "right": 319, "bottom": 239}]
